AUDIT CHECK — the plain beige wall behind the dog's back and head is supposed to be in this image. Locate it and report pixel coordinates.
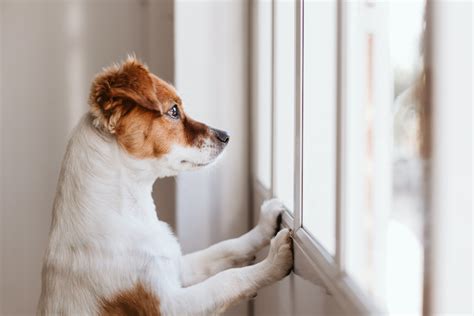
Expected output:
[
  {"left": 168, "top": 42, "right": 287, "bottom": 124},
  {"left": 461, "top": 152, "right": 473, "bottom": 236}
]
[{"left": 0, "top": 0, "right": 174, "bottom": 315}]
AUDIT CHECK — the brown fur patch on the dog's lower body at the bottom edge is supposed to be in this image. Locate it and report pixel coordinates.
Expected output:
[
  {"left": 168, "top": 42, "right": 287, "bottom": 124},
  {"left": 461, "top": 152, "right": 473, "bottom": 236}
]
[{"left": 99, "top": 283, "right": 160, "bottom": 316}]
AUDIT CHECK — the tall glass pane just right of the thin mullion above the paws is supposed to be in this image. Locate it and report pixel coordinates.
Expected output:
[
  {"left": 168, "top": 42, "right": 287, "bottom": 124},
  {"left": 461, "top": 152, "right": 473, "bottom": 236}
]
[{"left": 303, "top": 1, "right": 337, "bottom": 254}]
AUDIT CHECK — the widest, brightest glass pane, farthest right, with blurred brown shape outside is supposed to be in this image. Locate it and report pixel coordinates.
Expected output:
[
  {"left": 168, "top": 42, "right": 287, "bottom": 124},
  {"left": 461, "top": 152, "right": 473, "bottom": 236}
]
[{"left": 343, "top": 0, "right": 428, "bottom": 315}]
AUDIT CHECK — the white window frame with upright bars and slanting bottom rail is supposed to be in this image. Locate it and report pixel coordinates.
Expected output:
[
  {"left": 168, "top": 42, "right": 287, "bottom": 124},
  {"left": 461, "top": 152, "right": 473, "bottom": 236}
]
[{"left": 253, "top": 0, "right": 381, "bottom": 315}]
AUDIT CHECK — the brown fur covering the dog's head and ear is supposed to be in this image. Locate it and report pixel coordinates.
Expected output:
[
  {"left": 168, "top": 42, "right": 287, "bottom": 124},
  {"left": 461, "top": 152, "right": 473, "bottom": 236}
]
[{"left": 89, "top": 58, "right": 212, "bottom": 159}]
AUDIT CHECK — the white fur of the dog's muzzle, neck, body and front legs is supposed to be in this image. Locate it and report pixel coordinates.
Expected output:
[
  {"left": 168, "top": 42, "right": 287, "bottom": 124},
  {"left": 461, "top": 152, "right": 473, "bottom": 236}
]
[{"left": 38, "top": 115, "right": 292, "bottom": 315}]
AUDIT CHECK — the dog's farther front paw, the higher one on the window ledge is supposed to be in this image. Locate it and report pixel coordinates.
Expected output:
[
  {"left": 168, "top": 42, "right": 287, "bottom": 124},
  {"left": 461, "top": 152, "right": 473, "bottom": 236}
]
[{"left": 258, "top": 199, "right": 285, "bottom": 240}]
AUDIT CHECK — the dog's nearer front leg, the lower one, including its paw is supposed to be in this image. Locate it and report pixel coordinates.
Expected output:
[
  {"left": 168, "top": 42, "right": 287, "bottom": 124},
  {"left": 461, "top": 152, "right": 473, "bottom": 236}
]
[{"left": 167, "top": 229, "right": 293, "bottom": 315}]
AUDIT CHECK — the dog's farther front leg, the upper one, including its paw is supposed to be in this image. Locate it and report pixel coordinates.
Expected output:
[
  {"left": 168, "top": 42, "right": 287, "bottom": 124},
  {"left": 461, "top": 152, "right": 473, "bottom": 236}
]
[{"left": 181, "top": 199, "right": 284, "bottom": 286}]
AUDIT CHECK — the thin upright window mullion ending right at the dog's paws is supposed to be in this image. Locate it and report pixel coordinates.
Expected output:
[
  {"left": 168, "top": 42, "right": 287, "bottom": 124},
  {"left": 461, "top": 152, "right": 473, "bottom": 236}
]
[{"left": 294, "top": 0, "right": 304, "bottom": 231}]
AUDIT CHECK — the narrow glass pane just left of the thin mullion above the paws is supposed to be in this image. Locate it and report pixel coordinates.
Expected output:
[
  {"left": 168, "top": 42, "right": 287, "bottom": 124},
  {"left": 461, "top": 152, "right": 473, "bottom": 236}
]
[{"left": 273, "top": 0, "right": 295, "bottom": 211}]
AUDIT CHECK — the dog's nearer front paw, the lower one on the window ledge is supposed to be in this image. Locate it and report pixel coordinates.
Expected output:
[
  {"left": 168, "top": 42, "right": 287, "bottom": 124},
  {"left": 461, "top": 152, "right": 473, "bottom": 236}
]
[{"left": 265, "top": 228, "right": 293, "bottom": 281}]
